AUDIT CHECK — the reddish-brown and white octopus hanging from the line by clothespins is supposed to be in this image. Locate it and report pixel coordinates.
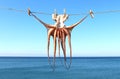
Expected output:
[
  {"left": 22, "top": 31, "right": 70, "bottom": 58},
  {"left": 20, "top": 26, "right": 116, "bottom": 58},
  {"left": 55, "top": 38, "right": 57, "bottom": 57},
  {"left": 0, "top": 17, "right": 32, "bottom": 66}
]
[{"left": 28, "top": 9, "right": 94, "bottom": 70}]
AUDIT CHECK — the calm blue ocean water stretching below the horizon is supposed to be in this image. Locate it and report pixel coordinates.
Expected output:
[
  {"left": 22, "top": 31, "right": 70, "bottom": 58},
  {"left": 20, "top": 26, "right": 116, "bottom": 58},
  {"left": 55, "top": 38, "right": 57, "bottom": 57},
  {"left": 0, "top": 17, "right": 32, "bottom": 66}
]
[{"left": 0, "top": 57, "right": 120, "bottom": 79}]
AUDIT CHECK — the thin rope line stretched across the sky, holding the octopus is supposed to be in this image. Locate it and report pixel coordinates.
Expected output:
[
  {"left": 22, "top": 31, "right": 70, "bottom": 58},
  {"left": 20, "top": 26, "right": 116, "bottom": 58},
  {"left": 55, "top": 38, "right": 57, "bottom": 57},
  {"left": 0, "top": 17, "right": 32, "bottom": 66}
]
[{"left": 0, "top": 7, "right": 120, "bottom": 16}]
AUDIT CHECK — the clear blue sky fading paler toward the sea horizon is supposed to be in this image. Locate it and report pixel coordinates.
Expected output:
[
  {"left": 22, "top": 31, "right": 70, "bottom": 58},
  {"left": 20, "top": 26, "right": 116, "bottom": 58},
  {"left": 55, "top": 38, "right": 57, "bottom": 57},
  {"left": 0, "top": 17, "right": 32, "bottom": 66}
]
[{"left": 0, "top": 0, "right": 120, "bottom": 56}]
